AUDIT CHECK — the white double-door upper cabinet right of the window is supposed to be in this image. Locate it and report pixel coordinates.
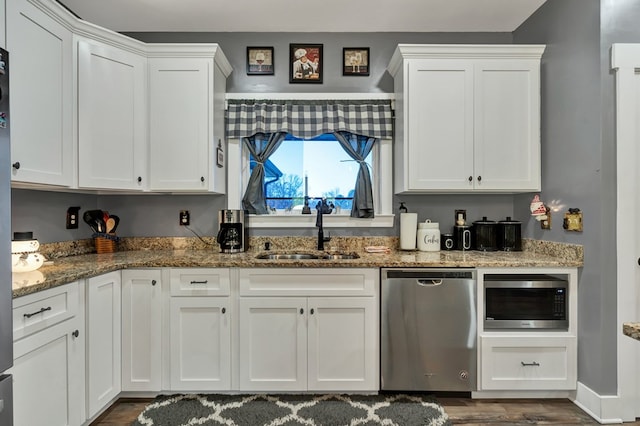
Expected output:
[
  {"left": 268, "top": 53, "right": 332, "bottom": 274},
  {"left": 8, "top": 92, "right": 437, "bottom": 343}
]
[{"left": 388, "top": 45, "right": 544, "bottom": 193}]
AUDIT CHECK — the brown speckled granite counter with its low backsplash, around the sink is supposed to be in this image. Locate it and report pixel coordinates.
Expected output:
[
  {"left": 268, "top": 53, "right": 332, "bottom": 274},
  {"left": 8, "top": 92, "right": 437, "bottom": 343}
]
[{"left": 13, "top": 237, "right": 583, "bottom": 298}]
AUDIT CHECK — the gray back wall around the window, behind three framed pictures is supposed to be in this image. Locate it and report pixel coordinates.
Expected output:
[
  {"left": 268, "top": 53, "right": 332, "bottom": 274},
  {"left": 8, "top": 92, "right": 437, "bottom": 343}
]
[{"left": 12, "top": 32, "right": 531, "bottom": 242}]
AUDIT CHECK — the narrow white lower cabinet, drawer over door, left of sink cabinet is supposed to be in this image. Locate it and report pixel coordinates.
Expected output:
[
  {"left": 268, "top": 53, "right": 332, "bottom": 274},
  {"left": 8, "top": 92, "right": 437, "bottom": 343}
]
[{"left": 169, "top": 268, "right": 233, "bottom": 391}]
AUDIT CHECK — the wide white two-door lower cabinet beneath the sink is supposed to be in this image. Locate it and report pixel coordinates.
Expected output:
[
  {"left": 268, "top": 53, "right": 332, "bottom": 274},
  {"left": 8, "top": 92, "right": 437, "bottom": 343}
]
[{"left": 239, "top": 269, "right": 379, "bottom": 391}]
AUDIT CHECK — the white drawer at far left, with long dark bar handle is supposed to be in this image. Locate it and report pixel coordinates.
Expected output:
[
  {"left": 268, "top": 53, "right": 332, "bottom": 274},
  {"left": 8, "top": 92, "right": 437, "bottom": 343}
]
[{"left": 13, "top": 282, "right": 79, "bottom": 341}]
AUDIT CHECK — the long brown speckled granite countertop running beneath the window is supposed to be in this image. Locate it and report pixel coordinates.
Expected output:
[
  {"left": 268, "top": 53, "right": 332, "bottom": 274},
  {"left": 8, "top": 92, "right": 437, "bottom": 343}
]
[{"left": 13, "top": 238, "right": 582, "bottom": 298}]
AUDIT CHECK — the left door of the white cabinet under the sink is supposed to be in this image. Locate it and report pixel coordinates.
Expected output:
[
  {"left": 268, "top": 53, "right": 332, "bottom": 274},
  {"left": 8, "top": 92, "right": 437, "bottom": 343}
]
[{"left": 240, "top": 297, "right": 307, "bottom": 391}]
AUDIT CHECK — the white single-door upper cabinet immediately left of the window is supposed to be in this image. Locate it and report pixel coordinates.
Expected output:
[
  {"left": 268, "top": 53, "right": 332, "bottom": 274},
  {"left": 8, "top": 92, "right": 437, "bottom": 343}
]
[{"left": 149, "top": 45, "right": 231, "bottom": 193}]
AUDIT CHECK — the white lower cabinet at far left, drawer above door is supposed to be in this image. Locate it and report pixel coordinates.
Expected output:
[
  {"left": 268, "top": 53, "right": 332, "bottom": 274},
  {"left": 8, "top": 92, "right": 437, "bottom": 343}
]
[{"left": 9, "top": 282, "right": 85, "bottom": 426}]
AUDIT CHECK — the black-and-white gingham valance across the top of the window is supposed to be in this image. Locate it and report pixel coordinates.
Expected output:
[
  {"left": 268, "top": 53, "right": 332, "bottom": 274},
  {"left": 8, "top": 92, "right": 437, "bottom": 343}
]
[{"left": 227, "top": 100, "right": 393, "bottom": 139}]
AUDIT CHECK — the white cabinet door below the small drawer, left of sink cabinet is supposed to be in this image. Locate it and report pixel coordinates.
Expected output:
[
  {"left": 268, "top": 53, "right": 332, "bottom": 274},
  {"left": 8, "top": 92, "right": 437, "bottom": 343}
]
[{"left": 170, "top": 297, "right": 231, "bottom": 391}]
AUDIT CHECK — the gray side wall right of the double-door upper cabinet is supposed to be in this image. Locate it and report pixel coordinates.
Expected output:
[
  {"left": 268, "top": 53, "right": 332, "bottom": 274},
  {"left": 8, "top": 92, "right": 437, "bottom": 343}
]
[{"left": 514, "top": 0, "right": 616, "bottom": 395}]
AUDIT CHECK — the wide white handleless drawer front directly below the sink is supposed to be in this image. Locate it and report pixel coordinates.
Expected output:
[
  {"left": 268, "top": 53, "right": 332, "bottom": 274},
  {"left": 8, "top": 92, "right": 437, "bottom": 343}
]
[{"left": 240, "top": 268, "right": 379, "bottom": 296}]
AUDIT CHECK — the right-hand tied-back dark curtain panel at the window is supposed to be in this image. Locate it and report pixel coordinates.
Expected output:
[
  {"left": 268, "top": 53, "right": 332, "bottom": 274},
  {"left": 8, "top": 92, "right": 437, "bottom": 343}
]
[{"left": 333, "top": 132, "right": 376, "bottom": 218}]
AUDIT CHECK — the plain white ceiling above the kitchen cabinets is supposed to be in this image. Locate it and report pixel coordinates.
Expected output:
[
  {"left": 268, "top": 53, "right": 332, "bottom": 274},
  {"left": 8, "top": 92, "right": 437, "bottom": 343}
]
[{"left": 58, "top": 0, "right": 546, "bottom": 32}]
